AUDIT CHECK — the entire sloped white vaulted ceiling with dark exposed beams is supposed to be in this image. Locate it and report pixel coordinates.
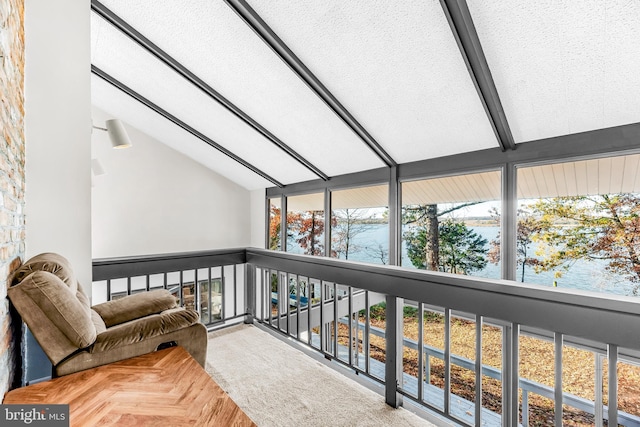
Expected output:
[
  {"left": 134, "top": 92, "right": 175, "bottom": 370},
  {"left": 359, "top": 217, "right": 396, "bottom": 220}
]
[{"left": 91, "top": 0, "right": 640, "bottom": 189}]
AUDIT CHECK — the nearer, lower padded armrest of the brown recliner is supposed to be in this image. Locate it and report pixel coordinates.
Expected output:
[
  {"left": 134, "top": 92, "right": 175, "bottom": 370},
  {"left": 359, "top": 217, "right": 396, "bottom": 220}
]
[{"left": 90, "top": 307, "right": 199, "bottom": 353}]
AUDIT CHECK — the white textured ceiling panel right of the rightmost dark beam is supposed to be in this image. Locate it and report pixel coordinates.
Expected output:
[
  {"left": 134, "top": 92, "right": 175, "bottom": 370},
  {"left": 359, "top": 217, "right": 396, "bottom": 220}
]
[{"left": 468, "top": 0, "right": 640, "bottom": 142}]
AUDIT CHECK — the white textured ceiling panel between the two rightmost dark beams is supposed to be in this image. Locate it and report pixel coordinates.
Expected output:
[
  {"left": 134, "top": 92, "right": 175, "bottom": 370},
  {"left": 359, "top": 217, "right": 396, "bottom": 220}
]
[{"left": 249, "top": 0, "right": 498, "bottom": 163}]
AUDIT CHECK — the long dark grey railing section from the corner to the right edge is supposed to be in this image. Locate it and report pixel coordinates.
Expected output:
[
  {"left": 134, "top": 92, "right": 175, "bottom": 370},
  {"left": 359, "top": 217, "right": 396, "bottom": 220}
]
[{"left": 247, "top": 249, "right": 640, "bottom": 426}]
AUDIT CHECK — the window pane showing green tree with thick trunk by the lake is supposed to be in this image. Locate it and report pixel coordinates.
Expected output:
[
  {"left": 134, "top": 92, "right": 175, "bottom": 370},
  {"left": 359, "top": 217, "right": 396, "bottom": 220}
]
[{"left": 401, "top": 171, "right": 501, "bottom": 279}]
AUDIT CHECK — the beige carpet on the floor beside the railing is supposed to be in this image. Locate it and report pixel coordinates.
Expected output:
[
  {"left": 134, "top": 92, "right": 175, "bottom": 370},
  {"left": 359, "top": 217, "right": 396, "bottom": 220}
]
[{"left": 206, "top": 325, "right": 433, "bottom": 427}]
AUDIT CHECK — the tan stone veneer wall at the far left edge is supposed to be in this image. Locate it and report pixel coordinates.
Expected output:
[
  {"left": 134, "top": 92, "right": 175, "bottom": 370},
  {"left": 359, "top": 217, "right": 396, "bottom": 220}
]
[{"left": 0, "top": 0, "right": 25, "bottom": 400}]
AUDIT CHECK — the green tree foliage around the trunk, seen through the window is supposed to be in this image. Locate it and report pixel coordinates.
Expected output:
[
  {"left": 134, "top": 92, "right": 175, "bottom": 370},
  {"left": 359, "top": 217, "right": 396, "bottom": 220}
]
[{"left": 404, "top": 219, "right": 487, "bottom": 274}]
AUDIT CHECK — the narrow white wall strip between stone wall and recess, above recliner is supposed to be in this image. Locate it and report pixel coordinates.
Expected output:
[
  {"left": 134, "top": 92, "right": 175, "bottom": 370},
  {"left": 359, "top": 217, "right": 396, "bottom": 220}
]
[{"left": 25, "top": 0, "right": 91, "bottom": 292}]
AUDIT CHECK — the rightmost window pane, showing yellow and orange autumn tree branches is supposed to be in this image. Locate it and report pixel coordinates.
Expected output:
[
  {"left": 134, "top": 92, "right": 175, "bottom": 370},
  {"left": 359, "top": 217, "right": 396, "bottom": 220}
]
[{"left": 517, "top": 154, "right": 640, "bottom": 295}]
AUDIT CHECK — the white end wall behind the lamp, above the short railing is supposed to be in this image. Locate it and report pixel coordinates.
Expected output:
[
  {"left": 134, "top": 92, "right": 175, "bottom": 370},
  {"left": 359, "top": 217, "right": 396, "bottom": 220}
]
[{"left": 91, "top": 107, "right": 253, "bottom": 258}]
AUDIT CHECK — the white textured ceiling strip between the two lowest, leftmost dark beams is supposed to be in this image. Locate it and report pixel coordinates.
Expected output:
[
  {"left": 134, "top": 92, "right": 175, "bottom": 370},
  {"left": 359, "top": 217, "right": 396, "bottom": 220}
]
[{"left": 91, "top": 10, "right": 316, "bottom": 183}]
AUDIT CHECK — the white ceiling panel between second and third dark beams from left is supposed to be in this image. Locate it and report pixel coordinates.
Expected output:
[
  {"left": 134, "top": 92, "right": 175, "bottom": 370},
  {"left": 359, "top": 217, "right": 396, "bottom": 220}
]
[{"left": 95, "top": 0, "right": 383, "bottom": 180}]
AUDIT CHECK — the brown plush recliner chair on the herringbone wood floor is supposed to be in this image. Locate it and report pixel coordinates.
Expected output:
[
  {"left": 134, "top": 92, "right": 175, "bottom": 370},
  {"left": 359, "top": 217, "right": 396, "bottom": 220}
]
[{"left": 7, "top": 253, "right": 207, "bottom": 376}]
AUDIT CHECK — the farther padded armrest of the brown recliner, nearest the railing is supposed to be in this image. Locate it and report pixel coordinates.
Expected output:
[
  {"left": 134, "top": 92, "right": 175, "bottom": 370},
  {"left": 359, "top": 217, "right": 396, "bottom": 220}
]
[{"left": 92, "top": 289, "right": 177, "bottom": 328}]
